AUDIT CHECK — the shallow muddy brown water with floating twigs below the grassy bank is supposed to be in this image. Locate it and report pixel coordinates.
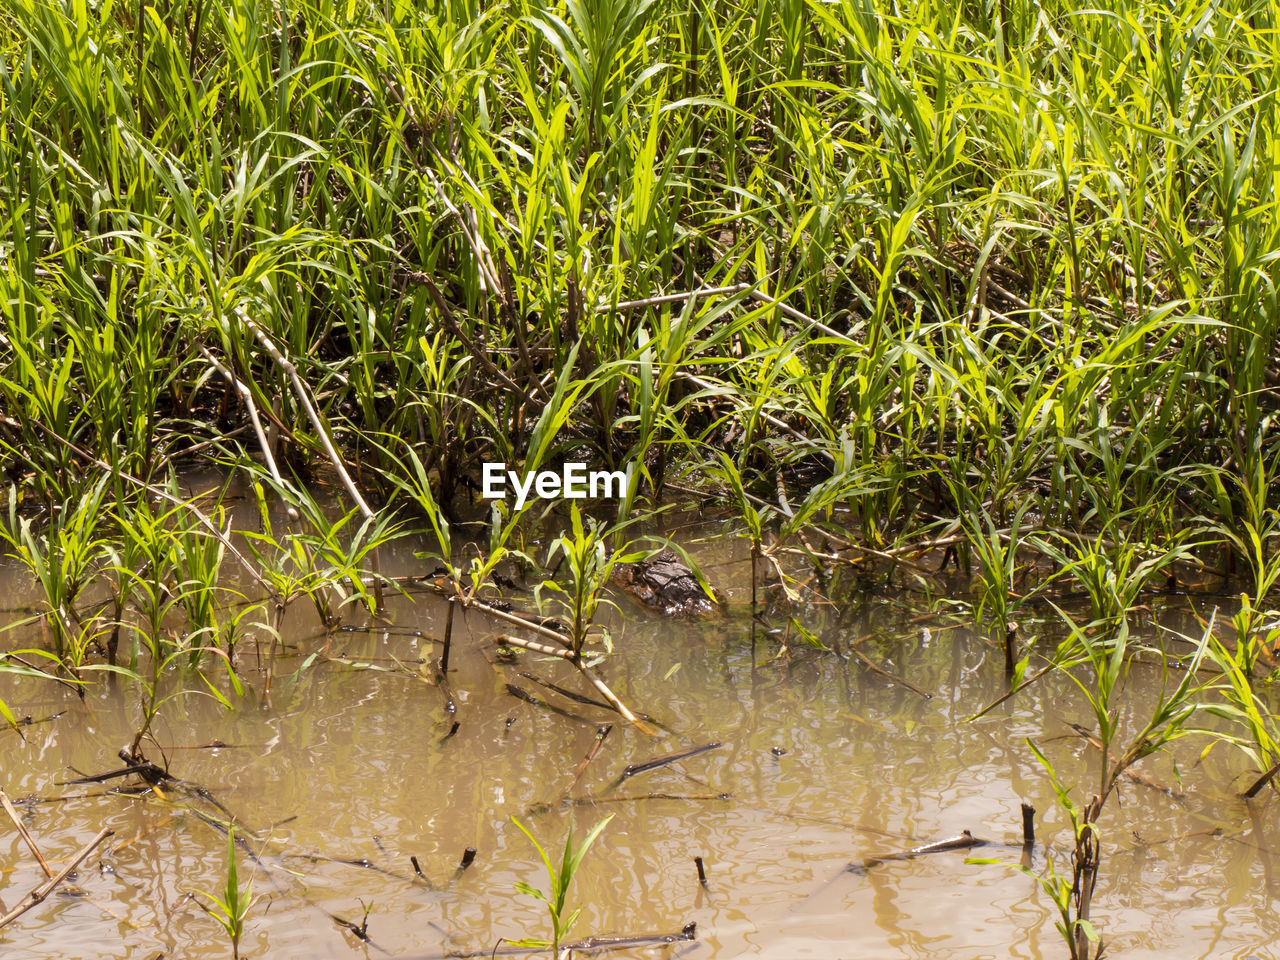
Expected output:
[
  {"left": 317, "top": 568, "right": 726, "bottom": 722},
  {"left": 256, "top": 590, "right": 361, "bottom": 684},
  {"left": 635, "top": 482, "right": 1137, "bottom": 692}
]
[{"left": 0, "top": 522, "right": 1280, "bottom": 960}]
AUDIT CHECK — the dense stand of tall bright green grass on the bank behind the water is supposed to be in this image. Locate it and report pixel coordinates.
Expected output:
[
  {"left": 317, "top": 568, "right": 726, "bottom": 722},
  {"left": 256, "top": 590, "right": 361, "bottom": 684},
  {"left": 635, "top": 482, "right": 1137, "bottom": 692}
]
[{"left": 0, "top": 0, "right": 1280, "bottom": 601}]
